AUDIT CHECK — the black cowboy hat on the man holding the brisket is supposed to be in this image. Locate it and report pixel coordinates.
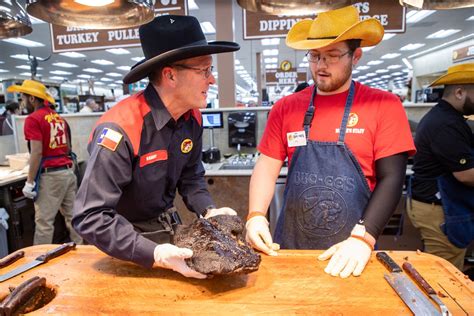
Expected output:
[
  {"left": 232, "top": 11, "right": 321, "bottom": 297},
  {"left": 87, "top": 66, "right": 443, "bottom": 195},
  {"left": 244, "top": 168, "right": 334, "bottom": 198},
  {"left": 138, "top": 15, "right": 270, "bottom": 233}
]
[{"left": 123, "top": 15, "right": 240, "bottom": 84}]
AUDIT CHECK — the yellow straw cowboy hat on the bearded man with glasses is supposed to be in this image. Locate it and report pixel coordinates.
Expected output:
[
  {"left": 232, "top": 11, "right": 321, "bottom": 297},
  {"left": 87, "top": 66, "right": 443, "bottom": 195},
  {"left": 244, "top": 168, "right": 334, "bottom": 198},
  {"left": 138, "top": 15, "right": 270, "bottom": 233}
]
[{"left": 286, "top": 6, "right": 384, "bottom": 50}]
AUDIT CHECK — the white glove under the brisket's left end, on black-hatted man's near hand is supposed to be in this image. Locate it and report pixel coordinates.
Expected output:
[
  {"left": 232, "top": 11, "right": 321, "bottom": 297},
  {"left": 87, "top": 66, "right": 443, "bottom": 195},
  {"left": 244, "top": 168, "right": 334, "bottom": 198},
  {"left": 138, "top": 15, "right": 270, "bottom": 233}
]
[{"left": 153, "top": 244, "right": 207, "bottom": 279}]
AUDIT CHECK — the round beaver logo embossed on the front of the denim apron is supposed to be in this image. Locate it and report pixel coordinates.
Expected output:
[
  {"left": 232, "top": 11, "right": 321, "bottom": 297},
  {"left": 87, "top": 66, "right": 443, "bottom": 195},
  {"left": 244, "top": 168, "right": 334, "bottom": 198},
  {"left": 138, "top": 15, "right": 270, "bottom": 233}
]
[{"left": 297, "top": 187, "right": 348, "bottom": 237}]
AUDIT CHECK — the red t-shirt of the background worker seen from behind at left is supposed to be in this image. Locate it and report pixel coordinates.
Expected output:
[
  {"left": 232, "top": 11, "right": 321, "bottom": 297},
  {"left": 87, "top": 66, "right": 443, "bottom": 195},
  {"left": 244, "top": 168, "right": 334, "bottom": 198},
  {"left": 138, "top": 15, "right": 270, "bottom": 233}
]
[{"left": 24, "top": 106, "right": 72, "bottom": 168}]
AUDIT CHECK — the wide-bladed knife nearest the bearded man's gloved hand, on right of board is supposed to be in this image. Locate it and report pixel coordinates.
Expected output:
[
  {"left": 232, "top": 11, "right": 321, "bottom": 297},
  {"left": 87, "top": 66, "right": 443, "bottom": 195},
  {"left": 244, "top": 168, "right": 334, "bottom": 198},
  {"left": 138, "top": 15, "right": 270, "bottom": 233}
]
[{"left": 376, "top": 251, "right": 441, "bottom": 316}]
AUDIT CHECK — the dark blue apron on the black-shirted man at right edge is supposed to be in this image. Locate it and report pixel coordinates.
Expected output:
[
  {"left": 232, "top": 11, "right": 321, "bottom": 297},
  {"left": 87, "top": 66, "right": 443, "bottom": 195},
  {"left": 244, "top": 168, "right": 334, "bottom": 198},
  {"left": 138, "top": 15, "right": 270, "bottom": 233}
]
[{"left": 437, "top": 173, "right": 474, "bottom": 248}]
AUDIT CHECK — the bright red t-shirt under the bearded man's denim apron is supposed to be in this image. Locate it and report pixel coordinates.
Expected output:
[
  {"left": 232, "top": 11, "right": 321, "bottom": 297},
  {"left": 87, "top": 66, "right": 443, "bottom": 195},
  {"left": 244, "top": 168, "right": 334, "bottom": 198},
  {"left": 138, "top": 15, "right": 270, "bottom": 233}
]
[{"left": 258, "top": 82, "right": 415, "bottom": 190}]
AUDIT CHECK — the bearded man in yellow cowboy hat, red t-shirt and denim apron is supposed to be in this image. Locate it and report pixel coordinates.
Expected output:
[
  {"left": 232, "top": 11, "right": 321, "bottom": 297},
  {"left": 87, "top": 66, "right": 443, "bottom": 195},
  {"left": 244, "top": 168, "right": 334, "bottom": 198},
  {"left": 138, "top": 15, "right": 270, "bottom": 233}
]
[{"left": 246, "top": 6, "right": 415, "bottom": 278}]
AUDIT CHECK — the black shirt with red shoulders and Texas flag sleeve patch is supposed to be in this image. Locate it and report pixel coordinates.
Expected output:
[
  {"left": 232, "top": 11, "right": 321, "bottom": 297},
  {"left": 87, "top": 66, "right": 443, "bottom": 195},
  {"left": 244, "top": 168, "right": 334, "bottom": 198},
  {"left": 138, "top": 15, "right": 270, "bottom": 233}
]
[{"left": 73, "top": 85, "right": 213, "bottom": 267}]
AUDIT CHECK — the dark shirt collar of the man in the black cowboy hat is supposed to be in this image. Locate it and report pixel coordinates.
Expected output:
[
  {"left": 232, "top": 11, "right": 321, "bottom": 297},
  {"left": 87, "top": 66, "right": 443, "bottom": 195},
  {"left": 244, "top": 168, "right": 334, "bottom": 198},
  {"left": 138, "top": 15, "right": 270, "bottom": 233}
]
[{"left": 145, "top": 83, "right": 196, "bottom": 130}]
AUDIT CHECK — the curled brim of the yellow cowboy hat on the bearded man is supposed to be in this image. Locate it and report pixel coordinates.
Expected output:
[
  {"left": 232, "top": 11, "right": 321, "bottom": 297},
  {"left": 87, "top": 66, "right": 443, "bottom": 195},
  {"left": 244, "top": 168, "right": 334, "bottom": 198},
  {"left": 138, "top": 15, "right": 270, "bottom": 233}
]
[{"left": 286, "top": 18, "right": 384, "bottom": 50}]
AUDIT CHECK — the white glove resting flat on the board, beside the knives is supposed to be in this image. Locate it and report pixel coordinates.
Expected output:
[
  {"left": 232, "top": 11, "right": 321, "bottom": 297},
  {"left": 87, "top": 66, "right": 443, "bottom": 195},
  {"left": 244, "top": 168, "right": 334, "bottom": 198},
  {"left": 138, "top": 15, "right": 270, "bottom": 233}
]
[{"left": 318, "top": 237, "right": 372, "bottom": 278}]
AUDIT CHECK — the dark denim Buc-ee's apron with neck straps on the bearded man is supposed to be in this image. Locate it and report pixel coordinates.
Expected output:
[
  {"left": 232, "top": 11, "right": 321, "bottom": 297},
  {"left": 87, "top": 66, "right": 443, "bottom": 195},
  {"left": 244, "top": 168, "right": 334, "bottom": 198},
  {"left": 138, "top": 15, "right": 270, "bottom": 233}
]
[{"left": 275, "top": 82, "right": 371, "bottom": 249}]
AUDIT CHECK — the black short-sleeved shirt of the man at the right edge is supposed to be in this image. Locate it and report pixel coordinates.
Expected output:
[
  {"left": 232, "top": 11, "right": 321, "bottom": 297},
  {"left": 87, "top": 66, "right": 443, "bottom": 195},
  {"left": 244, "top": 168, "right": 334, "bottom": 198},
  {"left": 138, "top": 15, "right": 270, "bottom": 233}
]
[{"left": 412, "top": 100, "right": 474, "bottom": 204}]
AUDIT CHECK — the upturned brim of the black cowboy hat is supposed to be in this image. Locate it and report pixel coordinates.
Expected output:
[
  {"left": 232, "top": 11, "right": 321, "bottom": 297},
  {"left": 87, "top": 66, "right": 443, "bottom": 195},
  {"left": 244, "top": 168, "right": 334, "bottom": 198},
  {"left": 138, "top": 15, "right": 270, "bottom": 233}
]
[{"left": 123, "top": 41, "right": 240, "bottom": 84}]
